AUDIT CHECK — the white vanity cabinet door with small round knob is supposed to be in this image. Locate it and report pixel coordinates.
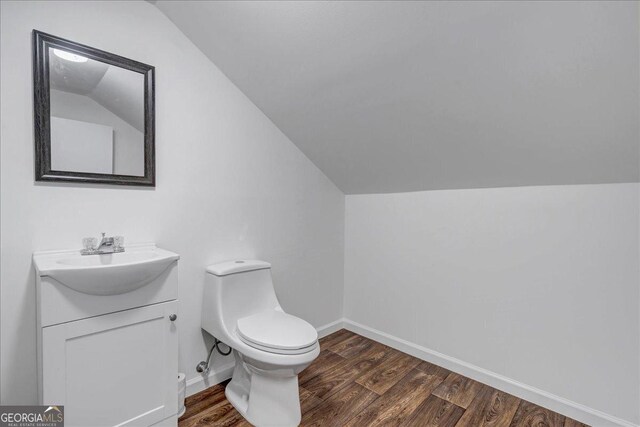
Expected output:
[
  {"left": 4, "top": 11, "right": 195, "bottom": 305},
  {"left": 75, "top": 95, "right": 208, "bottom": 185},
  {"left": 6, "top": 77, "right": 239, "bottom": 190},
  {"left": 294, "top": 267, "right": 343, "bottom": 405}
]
[{"left": 42, "top": 300, "right": 178, "bottom": 427}]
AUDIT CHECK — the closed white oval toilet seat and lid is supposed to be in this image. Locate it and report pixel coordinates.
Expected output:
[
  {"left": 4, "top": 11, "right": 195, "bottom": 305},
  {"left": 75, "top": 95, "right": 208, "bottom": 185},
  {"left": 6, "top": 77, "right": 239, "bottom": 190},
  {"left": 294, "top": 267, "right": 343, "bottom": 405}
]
[{"left": 237, "top": 310, "right": 318, "bottom": 354}]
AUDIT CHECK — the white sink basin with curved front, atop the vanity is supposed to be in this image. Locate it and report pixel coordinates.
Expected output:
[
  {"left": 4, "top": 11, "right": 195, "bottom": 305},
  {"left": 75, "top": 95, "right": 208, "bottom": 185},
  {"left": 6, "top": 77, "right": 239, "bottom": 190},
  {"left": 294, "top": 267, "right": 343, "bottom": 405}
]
[{"left": 33, "top": 245, "right": 180, "bottom": 295}]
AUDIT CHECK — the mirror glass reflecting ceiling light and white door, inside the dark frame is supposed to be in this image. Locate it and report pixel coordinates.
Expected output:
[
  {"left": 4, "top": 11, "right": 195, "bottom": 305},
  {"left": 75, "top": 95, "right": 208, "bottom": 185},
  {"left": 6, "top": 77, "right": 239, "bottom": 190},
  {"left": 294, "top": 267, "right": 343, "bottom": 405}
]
[{"left": 48, "top": 48, "right": 145, "bottom": 177}]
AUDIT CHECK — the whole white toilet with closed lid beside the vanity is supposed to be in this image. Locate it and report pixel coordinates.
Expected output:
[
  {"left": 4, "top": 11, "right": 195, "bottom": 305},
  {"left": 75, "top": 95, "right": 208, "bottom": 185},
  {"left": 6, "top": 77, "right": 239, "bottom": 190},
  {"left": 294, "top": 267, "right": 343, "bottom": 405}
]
[{"left": 202, "top": 260, "right": 320, "bottom": 426}]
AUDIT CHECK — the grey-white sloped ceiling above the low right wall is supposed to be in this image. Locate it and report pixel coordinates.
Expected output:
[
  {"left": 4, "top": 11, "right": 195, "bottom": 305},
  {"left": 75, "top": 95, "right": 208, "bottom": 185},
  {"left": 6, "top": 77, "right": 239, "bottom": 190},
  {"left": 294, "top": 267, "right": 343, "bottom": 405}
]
[{"left": 156, "top": 1, "right": 640, "bottom": 194}]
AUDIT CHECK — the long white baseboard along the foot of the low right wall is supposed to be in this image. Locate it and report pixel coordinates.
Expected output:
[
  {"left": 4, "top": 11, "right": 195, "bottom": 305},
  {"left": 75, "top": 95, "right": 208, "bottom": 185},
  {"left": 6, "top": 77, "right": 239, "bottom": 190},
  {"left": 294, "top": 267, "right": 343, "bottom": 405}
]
[{"left": 342, "top": 319, "right": 639, "bottom": 427}]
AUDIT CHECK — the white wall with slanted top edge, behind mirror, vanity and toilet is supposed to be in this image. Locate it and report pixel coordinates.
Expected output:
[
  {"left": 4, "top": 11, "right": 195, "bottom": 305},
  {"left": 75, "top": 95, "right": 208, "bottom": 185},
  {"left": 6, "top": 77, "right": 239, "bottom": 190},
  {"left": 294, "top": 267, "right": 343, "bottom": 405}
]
[{"left": 0, "top": 1, "right": 344, "bottom": 404}]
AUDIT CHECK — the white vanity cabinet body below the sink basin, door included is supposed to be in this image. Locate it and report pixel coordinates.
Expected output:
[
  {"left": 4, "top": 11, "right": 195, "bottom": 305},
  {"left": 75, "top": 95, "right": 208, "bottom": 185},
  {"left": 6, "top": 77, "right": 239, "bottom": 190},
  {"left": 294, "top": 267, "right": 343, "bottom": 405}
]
[{"left": 34, "top": 244, "right": 179, "bottom": 427}]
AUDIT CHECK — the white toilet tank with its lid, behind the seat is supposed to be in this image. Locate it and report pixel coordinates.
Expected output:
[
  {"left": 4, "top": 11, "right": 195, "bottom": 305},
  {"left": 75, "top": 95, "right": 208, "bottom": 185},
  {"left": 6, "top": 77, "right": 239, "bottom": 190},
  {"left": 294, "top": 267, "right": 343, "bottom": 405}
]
[{"left": 202, "top": 260, "right": 280, "bottom": 342}]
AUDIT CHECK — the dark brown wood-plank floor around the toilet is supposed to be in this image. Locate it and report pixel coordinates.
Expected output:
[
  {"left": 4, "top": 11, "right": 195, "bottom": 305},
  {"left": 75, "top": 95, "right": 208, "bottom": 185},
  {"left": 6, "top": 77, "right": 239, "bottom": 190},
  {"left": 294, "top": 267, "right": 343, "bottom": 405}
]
[{"left": 178, "top": 329, "right": 584, "bottom": 427}]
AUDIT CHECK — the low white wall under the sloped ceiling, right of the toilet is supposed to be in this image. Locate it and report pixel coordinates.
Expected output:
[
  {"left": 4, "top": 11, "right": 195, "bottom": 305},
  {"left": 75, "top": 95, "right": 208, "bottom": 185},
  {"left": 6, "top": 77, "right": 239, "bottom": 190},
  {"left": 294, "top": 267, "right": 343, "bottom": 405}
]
[{"left": 345, "top": 184, "right": 640, "bottom": 424}]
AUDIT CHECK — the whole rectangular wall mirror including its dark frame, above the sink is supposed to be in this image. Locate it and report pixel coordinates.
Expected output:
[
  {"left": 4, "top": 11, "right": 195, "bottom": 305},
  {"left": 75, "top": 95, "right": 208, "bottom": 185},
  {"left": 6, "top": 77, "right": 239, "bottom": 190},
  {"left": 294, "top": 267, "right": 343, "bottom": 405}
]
[{"left": 33, "top": 30, "right": 155, "bottom": 187}]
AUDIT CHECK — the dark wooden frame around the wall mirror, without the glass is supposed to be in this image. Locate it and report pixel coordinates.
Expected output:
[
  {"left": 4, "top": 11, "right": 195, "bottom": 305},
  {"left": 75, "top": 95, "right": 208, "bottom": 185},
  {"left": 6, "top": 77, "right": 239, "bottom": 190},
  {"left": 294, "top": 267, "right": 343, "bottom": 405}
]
[{"left": 33, "top": 30, "right": 156, "bottom": 187}]
